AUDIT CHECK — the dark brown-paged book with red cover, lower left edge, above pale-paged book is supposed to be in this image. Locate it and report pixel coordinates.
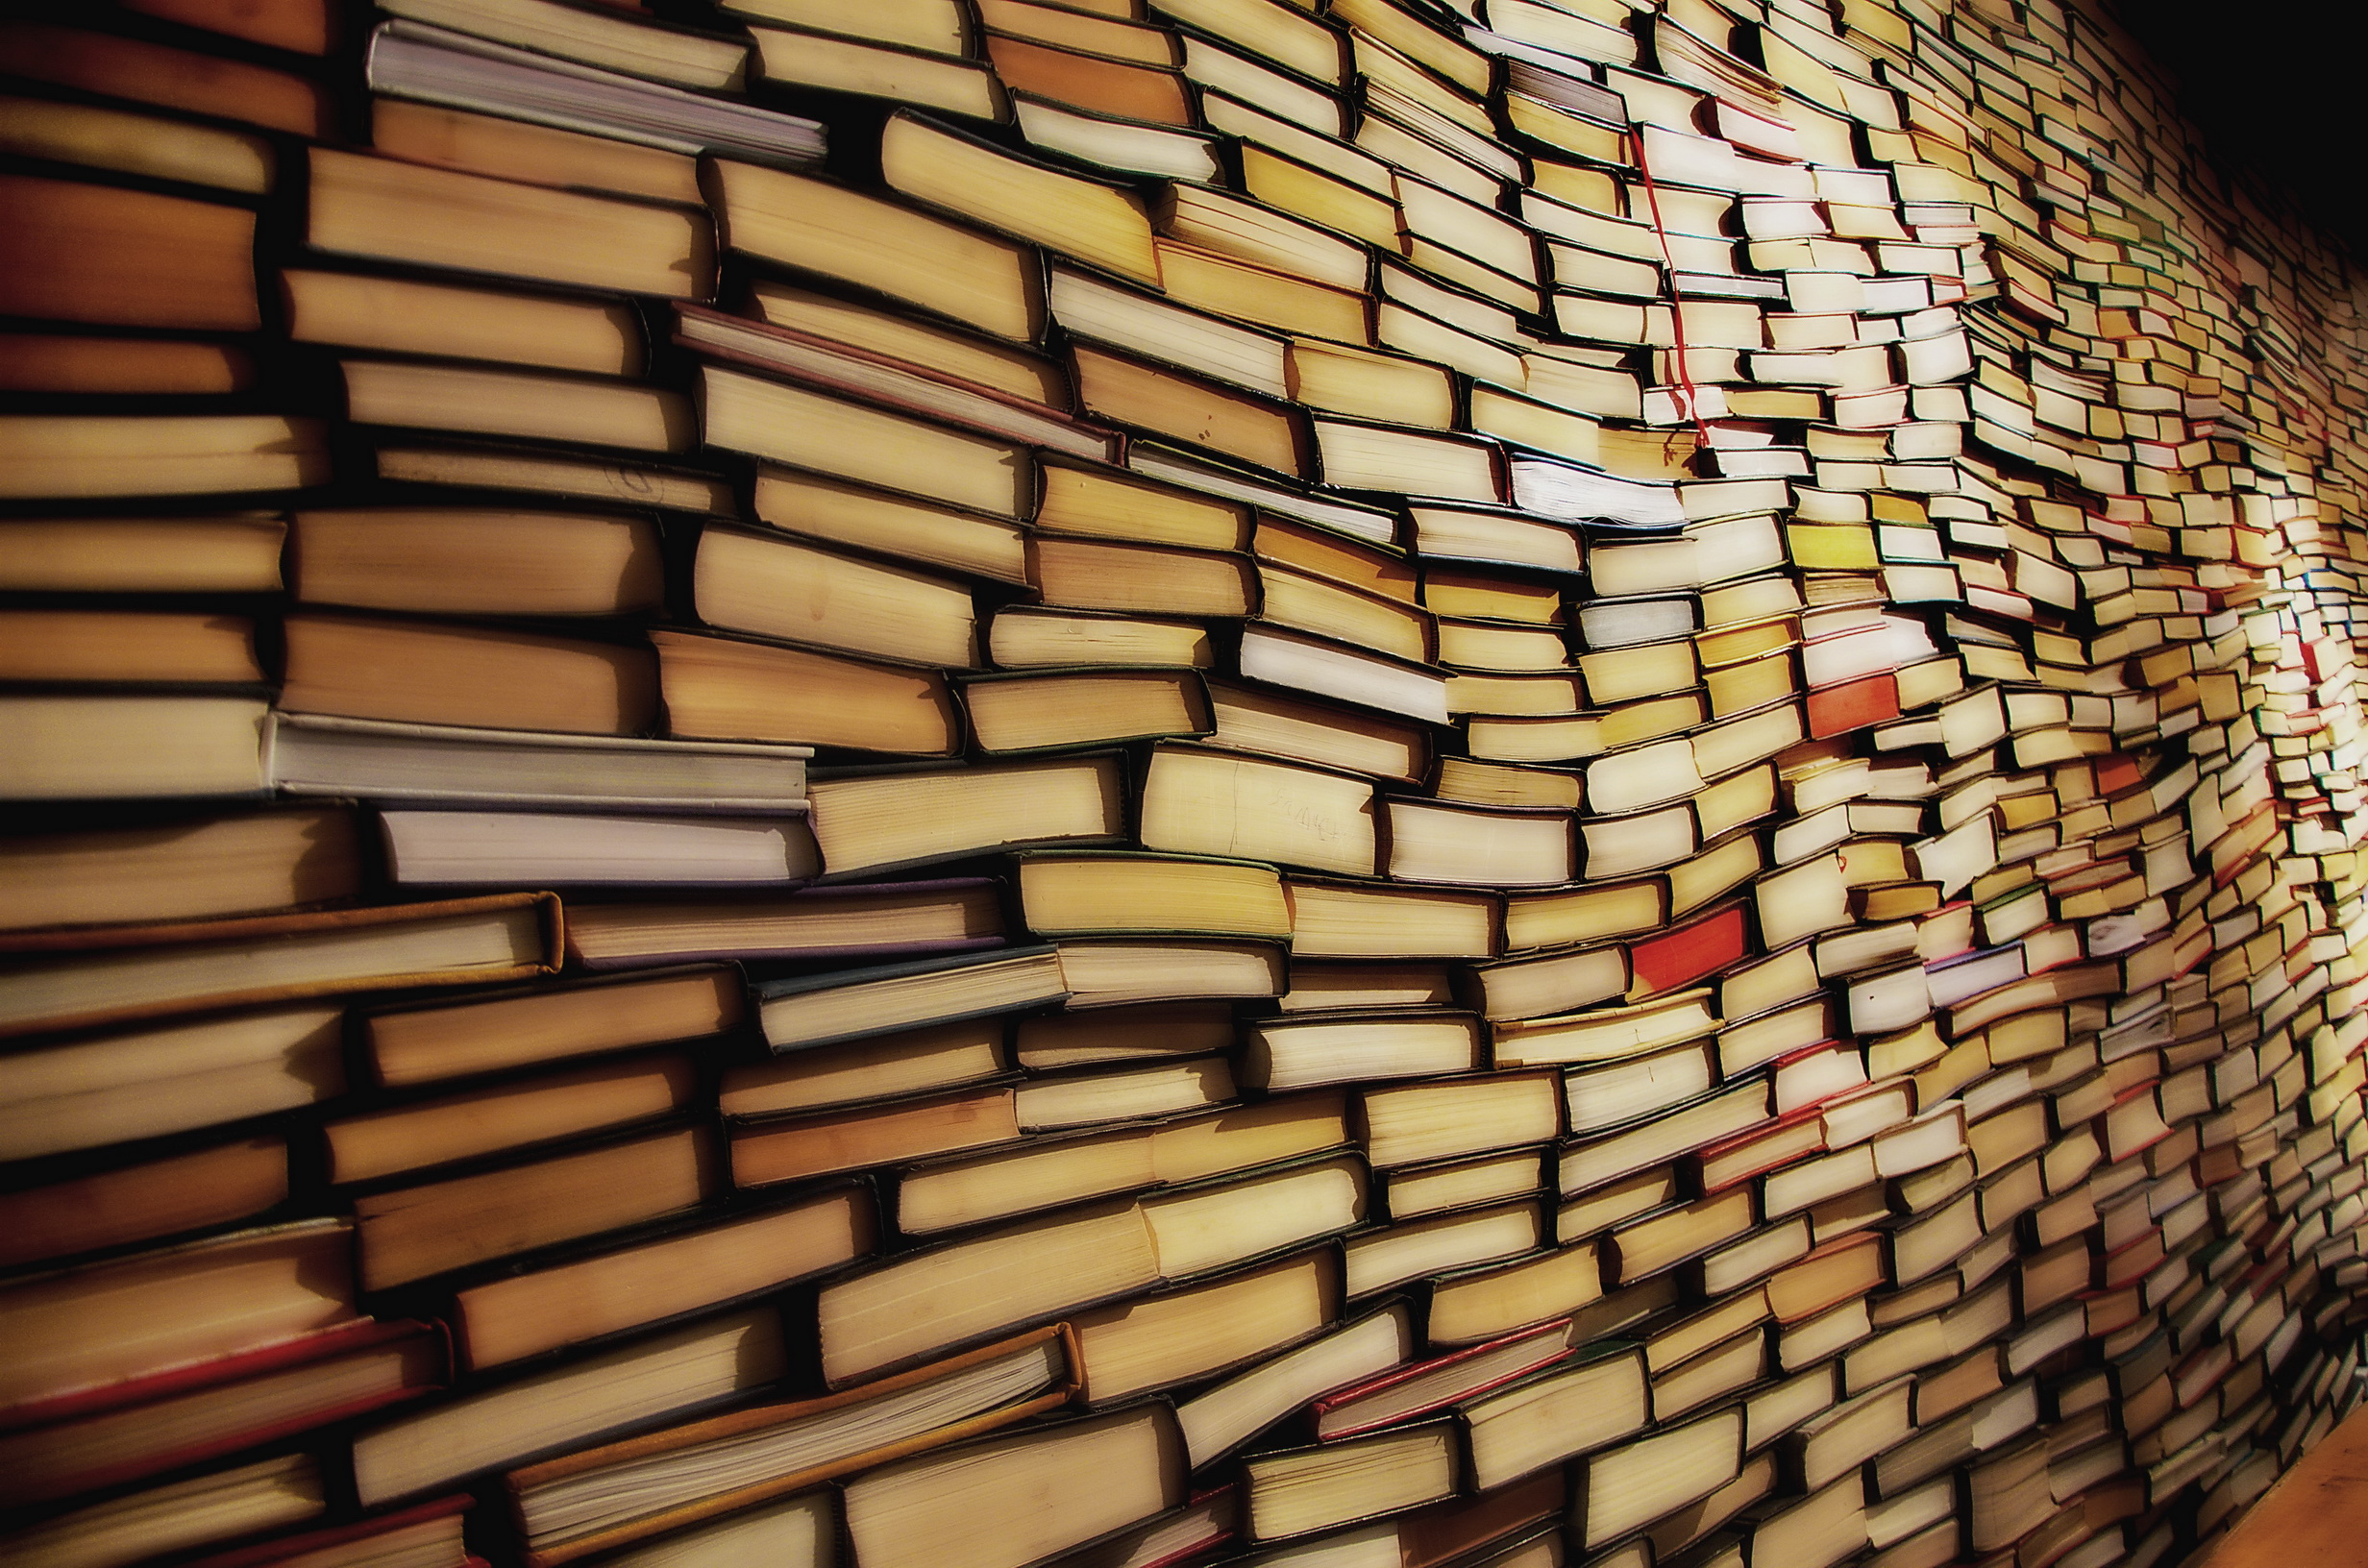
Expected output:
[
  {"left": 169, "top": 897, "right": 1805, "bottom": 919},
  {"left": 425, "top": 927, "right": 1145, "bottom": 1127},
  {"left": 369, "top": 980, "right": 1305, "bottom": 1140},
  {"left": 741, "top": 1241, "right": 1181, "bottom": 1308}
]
[{"left": 0, "top": 1317, "right": 453, "bottom": 1507}]
